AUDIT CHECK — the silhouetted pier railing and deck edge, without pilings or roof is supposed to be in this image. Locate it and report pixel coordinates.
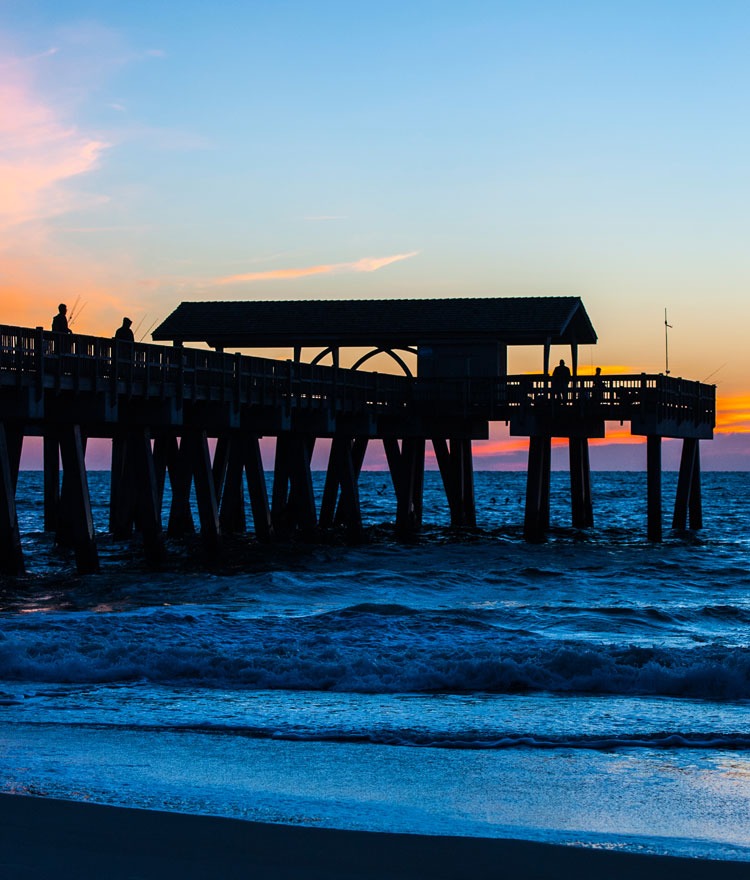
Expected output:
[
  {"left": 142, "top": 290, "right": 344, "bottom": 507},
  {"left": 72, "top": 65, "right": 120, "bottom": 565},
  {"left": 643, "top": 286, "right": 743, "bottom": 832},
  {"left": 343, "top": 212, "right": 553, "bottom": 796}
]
[{"left": 0, "top": 326, "right": 716, "bottom": 428}]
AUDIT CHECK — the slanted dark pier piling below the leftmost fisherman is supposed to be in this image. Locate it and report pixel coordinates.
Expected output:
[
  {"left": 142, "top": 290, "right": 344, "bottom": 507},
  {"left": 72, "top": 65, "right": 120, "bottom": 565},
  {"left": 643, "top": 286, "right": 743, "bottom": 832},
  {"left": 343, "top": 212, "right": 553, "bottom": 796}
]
[{"left": 60, "top": 425, "right": 99, "bottom": 574}]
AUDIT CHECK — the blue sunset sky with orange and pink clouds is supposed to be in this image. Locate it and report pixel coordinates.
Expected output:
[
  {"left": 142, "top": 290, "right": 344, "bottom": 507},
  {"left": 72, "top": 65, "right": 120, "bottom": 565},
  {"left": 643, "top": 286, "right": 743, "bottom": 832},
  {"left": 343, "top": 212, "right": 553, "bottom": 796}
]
[{"left": 0, "top": 0, "right": 750, "bottom": 470}]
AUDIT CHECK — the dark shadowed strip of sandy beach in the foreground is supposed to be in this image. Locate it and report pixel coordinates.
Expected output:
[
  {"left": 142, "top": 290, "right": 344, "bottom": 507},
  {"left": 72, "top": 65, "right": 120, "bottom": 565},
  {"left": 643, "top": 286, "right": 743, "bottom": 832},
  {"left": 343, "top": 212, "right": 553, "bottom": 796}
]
[{"left": 0, "top": 795, "right": 750, "bottom": 880}]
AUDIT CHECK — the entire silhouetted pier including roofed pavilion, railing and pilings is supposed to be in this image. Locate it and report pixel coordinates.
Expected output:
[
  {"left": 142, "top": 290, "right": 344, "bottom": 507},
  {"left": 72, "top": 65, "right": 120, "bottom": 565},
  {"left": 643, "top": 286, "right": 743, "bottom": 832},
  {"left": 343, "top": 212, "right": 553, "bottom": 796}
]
[{"left": 0, "top": 297, "right": 715, "bottom": 575}]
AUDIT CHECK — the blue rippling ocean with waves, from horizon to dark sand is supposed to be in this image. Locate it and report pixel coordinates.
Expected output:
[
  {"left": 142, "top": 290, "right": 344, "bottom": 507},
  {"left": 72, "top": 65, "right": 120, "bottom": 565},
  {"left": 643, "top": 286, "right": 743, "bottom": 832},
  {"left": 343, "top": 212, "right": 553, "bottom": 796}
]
[{"left": 0, "top": 472, "right": 750, "bottom": 861}]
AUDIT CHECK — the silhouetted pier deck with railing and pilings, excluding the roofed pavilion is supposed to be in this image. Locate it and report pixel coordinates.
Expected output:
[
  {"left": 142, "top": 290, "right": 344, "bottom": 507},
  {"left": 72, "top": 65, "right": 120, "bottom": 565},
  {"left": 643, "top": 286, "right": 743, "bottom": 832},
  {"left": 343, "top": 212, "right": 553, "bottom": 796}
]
[{"left": 0, "top": 326, "right": 715, "bottom": 573}]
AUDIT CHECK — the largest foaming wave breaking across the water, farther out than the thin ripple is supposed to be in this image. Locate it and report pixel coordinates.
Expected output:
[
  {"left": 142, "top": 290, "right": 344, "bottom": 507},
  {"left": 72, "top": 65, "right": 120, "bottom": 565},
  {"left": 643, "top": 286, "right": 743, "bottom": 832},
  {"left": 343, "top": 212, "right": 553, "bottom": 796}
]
[{"left": 0, "top": 605, "right": 750, "bottom": 700}]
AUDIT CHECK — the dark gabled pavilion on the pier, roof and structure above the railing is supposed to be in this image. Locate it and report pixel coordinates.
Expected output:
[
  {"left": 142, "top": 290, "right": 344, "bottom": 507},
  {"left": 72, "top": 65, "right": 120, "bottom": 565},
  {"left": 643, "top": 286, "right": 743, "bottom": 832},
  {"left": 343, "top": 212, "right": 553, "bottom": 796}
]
[{"left": 152, "top": 296, "right": 597, "bottom": 378}]
